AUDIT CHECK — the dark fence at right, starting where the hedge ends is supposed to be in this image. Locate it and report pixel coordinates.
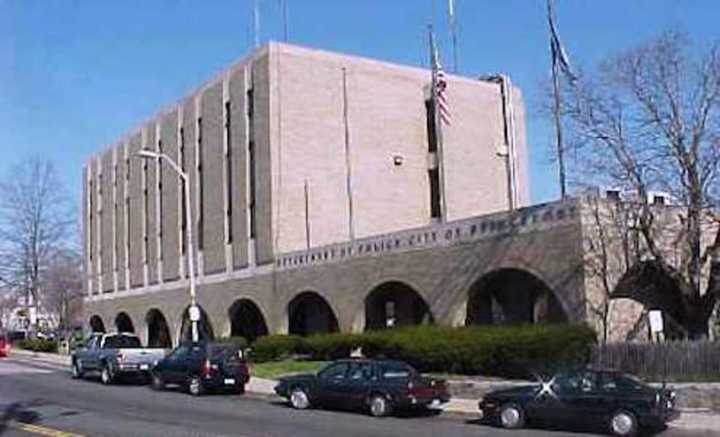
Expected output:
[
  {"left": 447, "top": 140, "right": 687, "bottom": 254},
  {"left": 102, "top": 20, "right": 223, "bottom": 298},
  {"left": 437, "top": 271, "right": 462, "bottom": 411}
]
[{"left": 592, "top": 341, "right": 720, "bottom": 381}]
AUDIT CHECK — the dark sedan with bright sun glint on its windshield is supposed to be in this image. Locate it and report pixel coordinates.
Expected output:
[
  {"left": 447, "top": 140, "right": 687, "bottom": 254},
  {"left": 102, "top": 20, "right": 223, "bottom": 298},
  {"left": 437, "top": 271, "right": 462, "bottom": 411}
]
[{"left": 479, "top": 369, "right": 678, "bottom": 436}]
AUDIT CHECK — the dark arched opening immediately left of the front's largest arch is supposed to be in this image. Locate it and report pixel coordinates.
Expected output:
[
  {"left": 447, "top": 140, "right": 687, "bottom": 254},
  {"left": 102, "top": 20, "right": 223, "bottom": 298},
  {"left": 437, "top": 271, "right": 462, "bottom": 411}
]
[{"left": 365, "top": 282, "right": 433, "bottom": 330}]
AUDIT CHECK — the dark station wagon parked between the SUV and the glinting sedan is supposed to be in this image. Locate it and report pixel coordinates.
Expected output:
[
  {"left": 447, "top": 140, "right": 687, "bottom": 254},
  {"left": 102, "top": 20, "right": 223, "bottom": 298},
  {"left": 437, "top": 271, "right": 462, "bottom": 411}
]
[{"left": 275, "top": 359, "right": 450, "bottom": 417}]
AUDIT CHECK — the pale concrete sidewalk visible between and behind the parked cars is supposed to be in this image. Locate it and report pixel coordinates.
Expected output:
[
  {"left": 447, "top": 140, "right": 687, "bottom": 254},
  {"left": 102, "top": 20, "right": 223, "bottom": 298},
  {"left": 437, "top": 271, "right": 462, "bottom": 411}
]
[{"left": 10, "top": 349, "right": 720, "bottom": 434}]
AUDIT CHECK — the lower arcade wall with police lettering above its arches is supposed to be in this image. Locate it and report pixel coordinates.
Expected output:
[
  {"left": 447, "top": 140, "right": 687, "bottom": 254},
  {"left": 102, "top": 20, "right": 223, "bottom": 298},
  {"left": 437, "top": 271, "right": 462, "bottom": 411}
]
[{"left": 85, "top": 199, "right": 586, "bottom": 341}]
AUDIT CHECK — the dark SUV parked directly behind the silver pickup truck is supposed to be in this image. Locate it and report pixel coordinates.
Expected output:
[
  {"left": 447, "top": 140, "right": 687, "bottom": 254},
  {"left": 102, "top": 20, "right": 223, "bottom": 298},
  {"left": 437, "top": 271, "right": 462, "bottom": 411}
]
[{"left": 151, "top": 342, "right": 250, "bottom": 396}]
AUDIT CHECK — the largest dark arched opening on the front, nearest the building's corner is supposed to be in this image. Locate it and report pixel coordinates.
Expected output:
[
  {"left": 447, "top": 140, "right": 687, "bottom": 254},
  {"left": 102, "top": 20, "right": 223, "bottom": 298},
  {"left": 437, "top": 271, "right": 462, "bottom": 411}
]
[{"left": 465, "top": 269, "right": 567, "bottom": 325}]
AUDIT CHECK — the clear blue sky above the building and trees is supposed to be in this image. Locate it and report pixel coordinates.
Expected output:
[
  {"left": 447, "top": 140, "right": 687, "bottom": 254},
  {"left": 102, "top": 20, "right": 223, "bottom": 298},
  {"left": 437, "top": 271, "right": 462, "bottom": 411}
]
[{"left": 0, "top": 0, "right": 720, "bottom": 202}]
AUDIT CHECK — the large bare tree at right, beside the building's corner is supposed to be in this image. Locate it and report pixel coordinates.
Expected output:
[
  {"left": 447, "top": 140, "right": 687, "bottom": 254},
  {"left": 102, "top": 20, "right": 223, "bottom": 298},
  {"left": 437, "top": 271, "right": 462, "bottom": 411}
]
[{"left": 563, "top": 32, "right": 720, "bottom": 337}]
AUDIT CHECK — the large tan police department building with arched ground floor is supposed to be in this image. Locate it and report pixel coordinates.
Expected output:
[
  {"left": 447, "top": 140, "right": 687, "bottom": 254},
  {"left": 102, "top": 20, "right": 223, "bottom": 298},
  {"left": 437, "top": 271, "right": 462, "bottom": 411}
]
[{"left": 84, "top": 43, "right": 704, "bottom": 346}]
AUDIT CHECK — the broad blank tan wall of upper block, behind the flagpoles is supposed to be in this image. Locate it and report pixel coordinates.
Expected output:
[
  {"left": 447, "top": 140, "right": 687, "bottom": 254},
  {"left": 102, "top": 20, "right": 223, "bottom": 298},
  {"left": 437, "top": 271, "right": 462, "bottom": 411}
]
[{"left": 270, "top": 45, "right": 527, "bottom": 253}]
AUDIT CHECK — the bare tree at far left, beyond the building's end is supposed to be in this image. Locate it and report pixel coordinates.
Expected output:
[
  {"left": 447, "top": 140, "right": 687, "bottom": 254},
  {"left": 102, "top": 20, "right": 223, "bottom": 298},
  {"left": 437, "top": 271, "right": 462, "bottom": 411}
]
[{"left": 0, "top": 159, "right": 74, "bottom": 328}]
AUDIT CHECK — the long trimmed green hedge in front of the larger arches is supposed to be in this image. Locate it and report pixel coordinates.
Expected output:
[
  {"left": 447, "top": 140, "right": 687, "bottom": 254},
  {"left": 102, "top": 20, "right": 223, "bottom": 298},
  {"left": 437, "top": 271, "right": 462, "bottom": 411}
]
[{"left": 252, "top": 324, "right": 596, "bottom": 378}]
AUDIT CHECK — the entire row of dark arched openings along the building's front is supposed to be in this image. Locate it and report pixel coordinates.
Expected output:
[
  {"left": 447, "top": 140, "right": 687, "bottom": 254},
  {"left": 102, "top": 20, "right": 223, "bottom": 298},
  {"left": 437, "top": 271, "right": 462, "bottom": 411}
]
[{"left": 89, "top": 269, "right": 567, "bottom": 347}]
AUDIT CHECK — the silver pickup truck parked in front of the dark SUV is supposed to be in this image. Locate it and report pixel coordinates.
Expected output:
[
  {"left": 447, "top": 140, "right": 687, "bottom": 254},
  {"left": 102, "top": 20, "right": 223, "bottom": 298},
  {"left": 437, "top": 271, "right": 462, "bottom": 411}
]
[{"left": 72, "top": 333, "right": 165, "bottom": 384}]
